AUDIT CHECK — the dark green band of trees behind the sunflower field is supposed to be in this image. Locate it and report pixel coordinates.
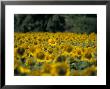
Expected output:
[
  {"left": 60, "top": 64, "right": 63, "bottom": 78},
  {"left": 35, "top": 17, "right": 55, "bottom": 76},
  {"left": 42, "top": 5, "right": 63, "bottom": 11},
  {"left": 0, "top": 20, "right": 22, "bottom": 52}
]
[{"left": 14, "top": 14, "right": 97, "bottom": 33}]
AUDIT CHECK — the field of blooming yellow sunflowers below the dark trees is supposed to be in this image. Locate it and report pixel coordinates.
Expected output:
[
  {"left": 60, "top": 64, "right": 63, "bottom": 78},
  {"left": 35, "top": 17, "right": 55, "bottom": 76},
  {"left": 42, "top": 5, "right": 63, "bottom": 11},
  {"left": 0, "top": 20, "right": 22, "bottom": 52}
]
[{"left": 14, "top": 32, "right": 97, "bottom": 76}]
